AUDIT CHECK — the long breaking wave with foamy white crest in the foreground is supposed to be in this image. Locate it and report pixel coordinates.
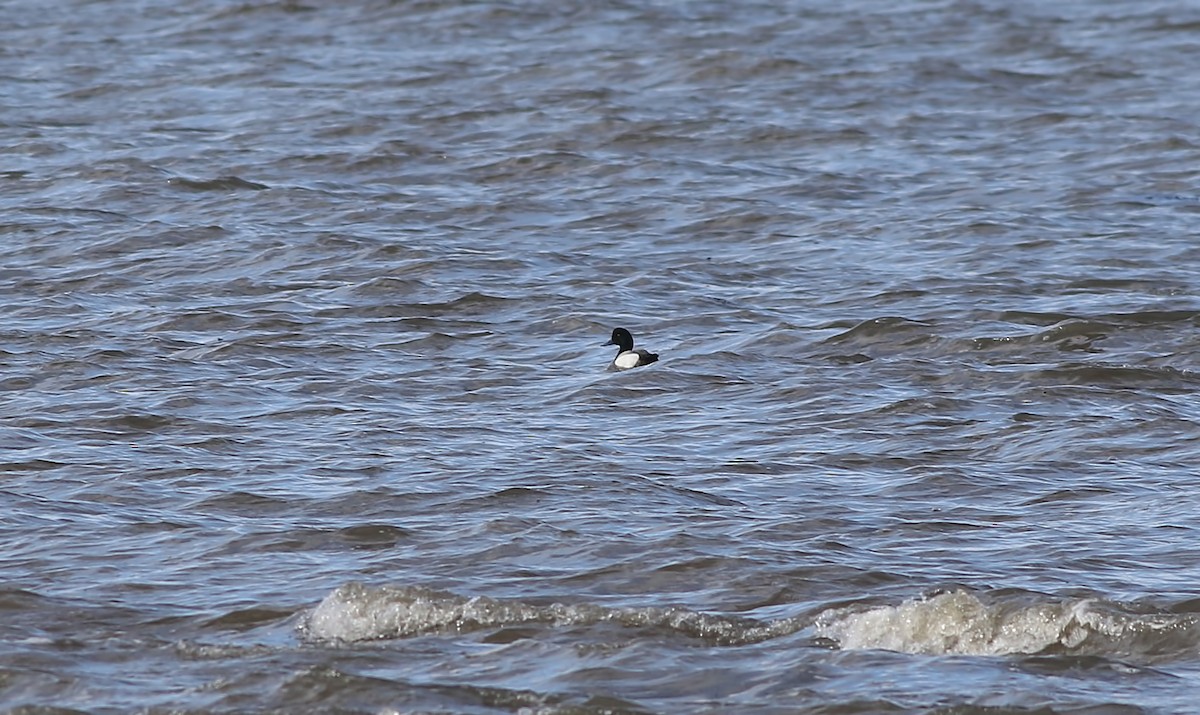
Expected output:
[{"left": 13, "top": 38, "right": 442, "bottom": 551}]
[{"left": 300, "top": 582, "right": 1200, "bottom": 661}]
